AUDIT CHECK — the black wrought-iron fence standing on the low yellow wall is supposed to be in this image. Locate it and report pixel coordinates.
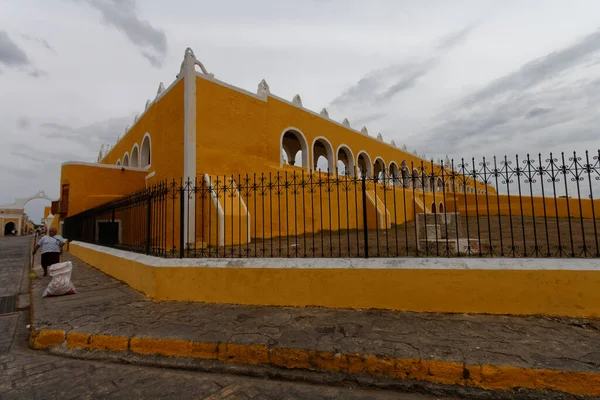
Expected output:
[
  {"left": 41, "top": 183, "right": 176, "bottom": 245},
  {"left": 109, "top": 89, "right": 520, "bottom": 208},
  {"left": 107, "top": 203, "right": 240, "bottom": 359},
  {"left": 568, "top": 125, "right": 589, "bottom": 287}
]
[{"left": 65, "top": 151, "right": 600, "bottom": 258}]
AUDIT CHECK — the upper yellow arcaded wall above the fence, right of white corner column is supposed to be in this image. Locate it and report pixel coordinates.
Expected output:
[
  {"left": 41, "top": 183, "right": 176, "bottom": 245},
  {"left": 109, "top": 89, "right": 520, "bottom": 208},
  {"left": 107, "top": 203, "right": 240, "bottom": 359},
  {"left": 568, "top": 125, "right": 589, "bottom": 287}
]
[{"left": 196, "top": 77, "right": 480, "bottom": 190}]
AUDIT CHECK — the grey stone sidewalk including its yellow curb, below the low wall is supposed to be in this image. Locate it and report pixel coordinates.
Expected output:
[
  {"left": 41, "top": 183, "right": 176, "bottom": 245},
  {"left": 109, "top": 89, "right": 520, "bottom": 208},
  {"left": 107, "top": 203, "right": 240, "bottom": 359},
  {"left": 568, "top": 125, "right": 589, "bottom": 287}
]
[{"left": 31, "top": 254, "right": 600, "bottom": 398}]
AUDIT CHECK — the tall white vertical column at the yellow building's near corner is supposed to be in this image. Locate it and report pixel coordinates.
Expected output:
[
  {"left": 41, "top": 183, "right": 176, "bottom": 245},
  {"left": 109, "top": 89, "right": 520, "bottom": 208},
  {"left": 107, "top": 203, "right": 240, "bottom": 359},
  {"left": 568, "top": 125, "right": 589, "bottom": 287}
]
[{"left": 183, "top": 47, "right": 196, "bottom": 247}]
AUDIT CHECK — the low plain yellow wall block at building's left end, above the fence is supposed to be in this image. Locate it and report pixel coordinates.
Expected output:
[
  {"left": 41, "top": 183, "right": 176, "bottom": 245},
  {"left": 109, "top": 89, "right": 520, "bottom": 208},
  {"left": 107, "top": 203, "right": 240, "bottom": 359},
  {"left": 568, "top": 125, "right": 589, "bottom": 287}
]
[{"left": 60, "top": 164, "right": 146, "bottom": 217}]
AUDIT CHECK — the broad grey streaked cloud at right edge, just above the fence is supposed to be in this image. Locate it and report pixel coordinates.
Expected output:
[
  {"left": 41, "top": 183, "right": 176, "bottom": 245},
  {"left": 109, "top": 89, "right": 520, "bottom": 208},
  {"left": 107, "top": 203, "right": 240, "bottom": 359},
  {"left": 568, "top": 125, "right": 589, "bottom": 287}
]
[{"left": 413, "top": 27, "right": 600, "bottom": 156}]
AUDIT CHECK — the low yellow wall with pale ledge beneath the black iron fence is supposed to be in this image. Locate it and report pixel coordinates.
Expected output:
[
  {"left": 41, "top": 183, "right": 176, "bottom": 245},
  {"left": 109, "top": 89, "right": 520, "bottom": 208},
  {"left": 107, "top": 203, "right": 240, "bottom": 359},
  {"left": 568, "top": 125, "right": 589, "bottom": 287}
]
[{"left": 70, "top": 242, "right": 600, "bottom": 317}]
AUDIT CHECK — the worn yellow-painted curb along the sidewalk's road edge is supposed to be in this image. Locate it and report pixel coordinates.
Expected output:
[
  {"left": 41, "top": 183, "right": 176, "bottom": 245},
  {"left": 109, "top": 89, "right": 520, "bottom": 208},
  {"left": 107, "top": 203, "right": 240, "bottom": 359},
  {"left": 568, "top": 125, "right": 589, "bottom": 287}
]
[{"left": 34, "top": 329, "right": 600, "bottom": 396}]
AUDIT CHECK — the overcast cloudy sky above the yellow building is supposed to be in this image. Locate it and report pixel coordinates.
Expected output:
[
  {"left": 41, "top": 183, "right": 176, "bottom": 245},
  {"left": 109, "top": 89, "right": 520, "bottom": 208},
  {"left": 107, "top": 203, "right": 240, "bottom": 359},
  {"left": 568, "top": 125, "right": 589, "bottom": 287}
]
[{"left": 0, "top": 0, "right": 600, "bottom": 217}]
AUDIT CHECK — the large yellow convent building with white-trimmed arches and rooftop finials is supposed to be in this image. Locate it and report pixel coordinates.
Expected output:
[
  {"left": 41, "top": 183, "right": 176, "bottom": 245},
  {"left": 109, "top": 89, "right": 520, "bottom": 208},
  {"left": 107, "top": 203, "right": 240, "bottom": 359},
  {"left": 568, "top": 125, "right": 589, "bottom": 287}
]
[{"left": 58, "top": 48, "right": 592, "bottom": 251}]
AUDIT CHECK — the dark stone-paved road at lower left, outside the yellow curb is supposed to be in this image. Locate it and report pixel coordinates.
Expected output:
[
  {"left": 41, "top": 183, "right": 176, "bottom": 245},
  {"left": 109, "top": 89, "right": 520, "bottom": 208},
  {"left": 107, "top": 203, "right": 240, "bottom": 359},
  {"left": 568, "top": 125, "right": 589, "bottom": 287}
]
[{"left": 0, "top": 238, "right": 450, "bottom": 400}]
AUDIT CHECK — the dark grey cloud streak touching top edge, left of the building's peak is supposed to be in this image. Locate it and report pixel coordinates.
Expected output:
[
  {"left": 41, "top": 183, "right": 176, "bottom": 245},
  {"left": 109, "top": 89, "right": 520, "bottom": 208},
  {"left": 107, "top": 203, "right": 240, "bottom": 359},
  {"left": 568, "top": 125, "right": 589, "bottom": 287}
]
[{"left": 83, "top": 0, "right": 167, "bottom": 68}]
